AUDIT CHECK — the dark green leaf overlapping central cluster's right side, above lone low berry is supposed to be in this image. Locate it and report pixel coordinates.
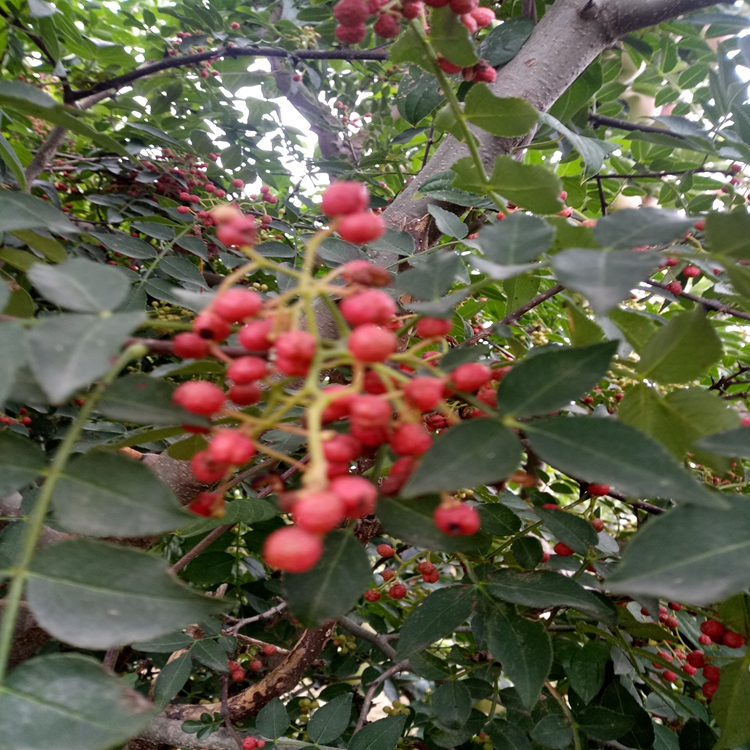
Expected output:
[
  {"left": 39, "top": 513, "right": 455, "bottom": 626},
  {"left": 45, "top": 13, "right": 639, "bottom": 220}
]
[{"left": 402, "top": 419, "right": 521, "bottom": 497}]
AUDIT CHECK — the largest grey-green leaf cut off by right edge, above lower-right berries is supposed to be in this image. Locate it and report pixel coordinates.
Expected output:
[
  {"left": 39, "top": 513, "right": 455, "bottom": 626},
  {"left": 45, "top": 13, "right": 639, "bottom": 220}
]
[{"left": 607, "top": 495, "right": 750, "bottom": 604}]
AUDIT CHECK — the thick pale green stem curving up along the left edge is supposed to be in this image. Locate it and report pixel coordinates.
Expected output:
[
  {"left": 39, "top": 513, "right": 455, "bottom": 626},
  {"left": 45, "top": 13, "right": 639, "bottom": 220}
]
[{"left": 0, "top": 344, "right": 147, "bottom": 687}]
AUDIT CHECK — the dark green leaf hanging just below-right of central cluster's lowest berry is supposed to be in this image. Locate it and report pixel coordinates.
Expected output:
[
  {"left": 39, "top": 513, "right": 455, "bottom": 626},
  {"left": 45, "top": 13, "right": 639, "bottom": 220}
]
[{"left": 284, "top": 531, "right": 372, "bottom": 626}]
